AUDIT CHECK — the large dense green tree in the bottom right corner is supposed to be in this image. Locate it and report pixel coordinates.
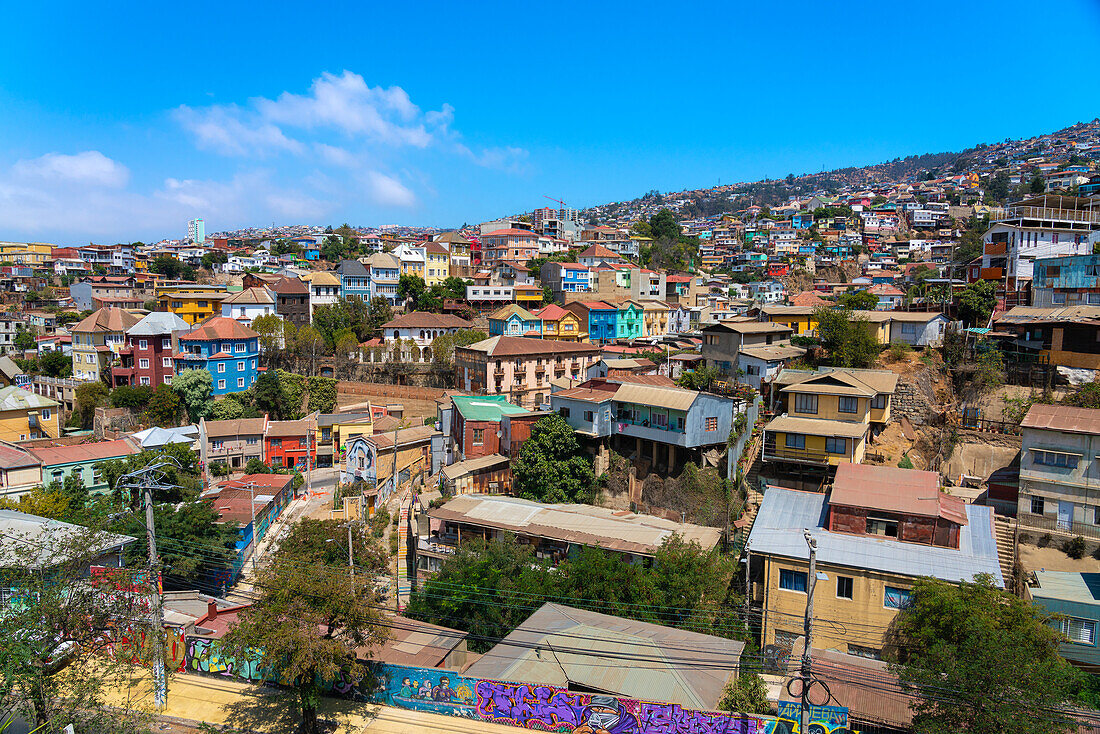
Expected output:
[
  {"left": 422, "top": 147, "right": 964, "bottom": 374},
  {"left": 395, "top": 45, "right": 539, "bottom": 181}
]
[{"left": 891, "top": 574, "right": 1079, "bottom": 734}]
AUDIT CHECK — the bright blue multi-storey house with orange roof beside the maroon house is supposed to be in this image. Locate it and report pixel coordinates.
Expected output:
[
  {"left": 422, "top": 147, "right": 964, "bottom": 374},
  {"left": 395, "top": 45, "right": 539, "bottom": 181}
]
[{"left": 176, "top": 316, "right": 260, "bottom": 395}]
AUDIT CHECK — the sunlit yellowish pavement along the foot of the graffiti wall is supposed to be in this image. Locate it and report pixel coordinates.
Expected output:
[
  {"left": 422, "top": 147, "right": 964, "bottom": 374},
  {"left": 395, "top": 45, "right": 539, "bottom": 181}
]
[{"left": 107, "top": 670, "right": 517, "bottom": 734}]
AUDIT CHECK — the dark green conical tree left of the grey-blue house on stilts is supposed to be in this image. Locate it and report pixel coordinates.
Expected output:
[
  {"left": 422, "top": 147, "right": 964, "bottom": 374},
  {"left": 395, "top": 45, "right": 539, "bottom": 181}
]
[{"left": 513, "top": 414, "right": 596, "bottom": 502}]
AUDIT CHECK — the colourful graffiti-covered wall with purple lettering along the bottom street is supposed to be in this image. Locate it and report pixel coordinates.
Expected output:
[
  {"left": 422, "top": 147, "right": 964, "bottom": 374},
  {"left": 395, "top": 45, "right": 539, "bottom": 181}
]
[{"left": 185, "top": 637, "right": 848, "bottom": 734}]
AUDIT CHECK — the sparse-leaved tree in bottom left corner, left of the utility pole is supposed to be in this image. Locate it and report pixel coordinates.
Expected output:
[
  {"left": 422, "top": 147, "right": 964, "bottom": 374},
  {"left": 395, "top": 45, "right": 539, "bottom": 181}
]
[{"left": 0, "top": 527, "right": 157, "bottom": 734}]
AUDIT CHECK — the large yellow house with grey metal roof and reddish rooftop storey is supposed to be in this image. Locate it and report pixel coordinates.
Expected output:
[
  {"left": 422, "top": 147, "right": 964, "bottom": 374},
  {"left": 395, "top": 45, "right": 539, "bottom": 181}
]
[{"left": 746, "top": 464, "right": 1003, "bottom": 658}]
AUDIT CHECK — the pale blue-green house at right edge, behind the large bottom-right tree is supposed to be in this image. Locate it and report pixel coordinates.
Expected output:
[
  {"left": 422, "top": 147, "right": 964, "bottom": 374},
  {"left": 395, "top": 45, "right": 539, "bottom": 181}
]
[{"left": 1024, "top": 571, "right": 1100, "bottom": 668}]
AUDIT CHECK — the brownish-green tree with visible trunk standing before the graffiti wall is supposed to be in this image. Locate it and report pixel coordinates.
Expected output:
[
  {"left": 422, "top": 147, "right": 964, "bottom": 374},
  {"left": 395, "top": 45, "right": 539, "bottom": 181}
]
[{"left": 219, "top": 554, "right": 386, "bottom": 734}]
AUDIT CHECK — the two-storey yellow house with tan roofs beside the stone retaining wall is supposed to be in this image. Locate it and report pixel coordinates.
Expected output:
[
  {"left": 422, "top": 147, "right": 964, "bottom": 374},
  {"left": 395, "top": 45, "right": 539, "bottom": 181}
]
[{"left": 762, "top": 368, "right": 898, "bottom": 467}]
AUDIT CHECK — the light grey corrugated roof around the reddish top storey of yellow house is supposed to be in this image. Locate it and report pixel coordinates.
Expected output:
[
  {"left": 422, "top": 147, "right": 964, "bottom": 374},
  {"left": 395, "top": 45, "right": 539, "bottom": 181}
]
[{"left": 749, "top": 486, "right": 1004, "bottom": 588}]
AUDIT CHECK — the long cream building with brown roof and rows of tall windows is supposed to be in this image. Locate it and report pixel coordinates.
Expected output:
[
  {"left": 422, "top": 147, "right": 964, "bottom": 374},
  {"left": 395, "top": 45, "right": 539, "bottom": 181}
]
[{"left": 454, "top": 336, "right": 600, "bottom": 408}]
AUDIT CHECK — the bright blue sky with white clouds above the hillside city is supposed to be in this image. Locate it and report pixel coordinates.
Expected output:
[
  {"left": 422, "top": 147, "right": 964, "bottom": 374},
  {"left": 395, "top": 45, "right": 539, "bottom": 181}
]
[{"left": 0, "top": 0, "right": 1100, "bottom": 243}]
